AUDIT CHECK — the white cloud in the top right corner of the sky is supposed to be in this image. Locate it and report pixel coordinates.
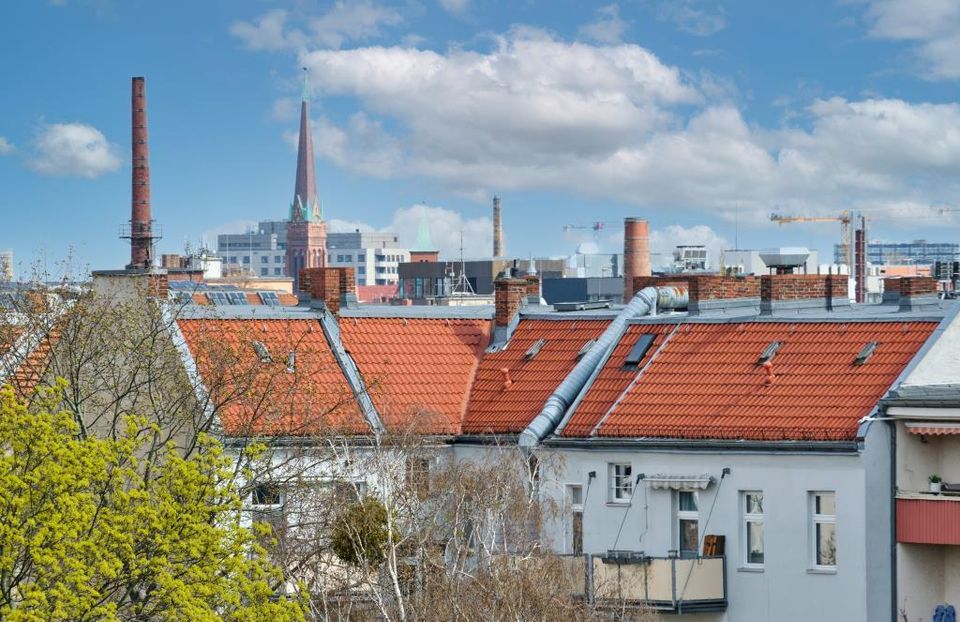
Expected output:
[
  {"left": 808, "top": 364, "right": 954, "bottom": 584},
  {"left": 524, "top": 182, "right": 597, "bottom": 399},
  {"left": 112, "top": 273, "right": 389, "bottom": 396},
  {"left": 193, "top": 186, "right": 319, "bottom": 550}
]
[{"left": 867, "top": 0, "right": 960, "bottom": 80}]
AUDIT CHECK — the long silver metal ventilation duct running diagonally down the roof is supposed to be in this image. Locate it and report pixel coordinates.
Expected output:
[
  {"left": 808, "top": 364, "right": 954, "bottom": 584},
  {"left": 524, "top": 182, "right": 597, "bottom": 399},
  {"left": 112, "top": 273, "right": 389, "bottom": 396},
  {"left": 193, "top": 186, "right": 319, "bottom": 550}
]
[{"left": 519, "top": 287, "right": 687, "bottom": 448}]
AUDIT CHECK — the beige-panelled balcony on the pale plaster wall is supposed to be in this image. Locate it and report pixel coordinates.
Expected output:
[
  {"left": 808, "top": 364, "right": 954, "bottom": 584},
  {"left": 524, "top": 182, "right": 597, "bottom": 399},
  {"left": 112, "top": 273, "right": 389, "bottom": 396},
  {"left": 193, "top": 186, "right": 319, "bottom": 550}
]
[{"left": 565, "top": 551, "right": 727, "bottom": 613}]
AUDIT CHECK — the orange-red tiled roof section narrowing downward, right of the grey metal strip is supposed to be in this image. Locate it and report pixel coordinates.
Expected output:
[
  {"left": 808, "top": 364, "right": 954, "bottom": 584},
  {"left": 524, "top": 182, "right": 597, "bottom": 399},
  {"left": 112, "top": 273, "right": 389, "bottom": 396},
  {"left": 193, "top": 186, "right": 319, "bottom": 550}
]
[{"left": 340, "top": 317, "right": 490, "bottom": 434}]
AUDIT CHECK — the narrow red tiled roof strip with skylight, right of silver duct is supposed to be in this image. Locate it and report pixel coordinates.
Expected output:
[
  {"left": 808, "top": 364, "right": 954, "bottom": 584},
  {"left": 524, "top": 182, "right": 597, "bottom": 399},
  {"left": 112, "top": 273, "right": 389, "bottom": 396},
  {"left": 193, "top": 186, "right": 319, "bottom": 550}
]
[{"left": 563, "top": 324, "right": 679, "bottom": 436}]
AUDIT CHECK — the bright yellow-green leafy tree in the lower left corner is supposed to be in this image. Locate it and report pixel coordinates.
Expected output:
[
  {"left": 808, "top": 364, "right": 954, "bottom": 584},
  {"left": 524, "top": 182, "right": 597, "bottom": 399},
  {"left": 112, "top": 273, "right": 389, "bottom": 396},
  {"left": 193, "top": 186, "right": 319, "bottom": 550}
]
[{"left": 0, "top": 382, "right": 302, "bottom": 622}]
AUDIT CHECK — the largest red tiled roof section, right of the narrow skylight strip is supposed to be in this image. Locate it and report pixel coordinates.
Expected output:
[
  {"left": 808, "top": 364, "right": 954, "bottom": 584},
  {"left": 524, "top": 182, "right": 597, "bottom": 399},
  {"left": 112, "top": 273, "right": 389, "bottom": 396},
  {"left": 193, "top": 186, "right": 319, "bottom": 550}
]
[{"left": 567, "top": 322, "right": 937, "bottom": 440}]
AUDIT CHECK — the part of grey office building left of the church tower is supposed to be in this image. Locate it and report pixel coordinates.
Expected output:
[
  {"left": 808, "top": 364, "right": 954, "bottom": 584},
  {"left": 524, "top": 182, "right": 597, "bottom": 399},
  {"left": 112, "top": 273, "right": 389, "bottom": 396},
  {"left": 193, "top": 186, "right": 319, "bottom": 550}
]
[{"left": 217, "top": 220, "right": 288, "bottom": 277}]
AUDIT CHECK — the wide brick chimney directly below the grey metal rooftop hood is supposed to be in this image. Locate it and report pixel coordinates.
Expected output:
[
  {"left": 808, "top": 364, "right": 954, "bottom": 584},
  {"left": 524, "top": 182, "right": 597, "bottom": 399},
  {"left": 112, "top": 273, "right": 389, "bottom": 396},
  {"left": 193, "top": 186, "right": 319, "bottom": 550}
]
[{"left": 760, "top": 274, "right": 850, "bottom": 314}]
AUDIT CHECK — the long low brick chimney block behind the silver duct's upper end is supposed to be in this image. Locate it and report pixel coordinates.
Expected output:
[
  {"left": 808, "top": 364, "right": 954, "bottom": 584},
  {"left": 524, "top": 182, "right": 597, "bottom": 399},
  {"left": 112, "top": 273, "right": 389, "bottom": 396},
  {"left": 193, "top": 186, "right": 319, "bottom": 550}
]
[{"left": 633, "top": 275, "right": 760, "bottom": 315}]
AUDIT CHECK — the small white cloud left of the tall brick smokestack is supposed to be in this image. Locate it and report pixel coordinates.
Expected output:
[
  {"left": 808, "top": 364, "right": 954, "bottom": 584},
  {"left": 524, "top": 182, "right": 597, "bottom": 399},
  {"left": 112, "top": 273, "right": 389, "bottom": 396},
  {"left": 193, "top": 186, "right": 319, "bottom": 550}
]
[{"left": 29, "top": 123, "right": 120, "bottom": 178}]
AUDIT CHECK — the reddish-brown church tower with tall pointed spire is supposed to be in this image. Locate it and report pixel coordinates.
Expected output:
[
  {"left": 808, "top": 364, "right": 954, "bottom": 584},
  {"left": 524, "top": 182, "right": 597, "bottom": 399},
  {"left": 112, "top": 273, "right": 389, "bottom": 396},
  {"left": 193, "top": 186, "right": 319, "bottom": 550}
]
[{"left": 287, "top": 67, "right": 327, "bottom": 291}]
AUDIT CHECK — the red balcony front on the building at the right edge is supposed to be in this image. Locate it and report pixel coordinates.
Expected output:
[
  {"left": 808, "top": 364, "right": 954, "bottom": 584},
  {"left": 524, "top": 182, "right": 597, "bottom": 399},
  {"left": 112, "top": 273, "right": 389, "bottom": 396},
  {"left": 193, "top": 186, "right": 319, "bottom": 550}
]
[{"left": 897, "top": 493, "right": 960, "bottom": 544}]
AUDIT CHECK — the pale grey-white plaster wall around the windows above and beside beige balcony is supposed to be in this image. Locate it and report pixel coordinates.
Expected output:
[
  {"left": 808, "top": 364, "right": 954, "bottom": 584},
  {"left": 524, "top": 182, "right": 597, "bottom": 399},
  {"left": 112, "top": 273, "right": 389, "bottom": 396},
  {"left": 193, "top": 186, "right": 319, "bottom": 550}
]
[{"left": 454, "top": 445, "right": 891, "bottom": 622}]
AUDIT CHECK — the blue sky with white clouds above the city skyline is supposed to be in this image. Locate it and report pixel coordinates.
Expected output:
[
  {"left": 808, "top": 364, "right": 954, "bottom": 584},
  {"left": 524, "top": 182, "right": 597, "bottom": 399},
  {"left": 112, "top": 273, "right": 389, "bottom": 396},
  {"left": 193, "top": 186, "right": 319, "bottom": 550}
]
[{"left": 0, "top": 0, "right": 960, "bottom": 275}]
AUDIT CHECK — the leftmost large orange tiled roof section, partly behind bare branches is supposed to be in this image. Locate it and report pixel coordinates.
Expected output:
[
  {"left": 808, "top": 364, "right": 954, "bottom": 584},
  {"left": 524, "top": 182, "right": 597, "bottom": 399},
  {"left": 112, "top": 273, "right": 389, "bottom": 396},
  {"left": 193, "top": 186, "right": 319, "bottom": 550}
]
[{"left": 178, "top": 319, "right": 369, "bottom": 436}]
